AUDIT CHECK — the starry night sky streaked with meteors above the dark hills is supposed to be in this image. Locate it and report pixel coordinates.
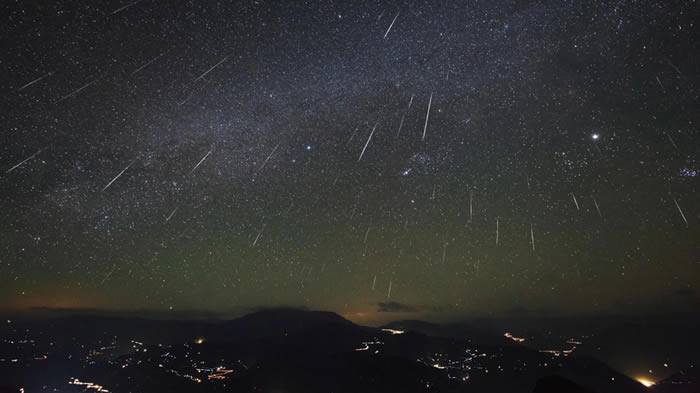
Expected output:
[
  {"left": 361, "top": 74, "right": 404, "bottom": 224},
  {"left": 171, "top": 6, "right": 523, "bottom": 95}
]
[{"left": 0, "top": 0, "right": 700, "bottom": 322}]
